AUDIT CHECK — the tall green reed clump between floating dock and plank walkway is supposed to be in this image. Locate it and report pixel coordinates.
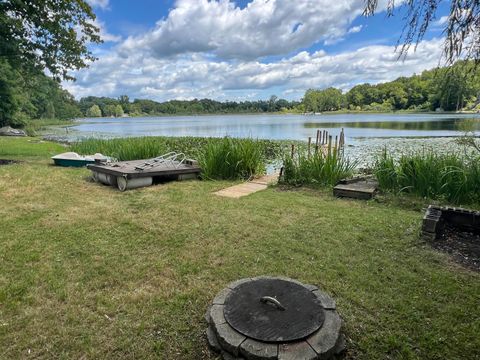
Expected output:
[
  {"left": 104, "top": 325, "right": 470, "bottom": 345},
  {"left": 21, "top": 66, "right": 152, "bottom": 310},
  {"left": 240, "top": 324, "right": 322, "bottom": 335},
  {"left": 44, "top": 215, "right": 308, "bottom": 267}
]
[{"left": 198, "top": 137, "right": 266, "bottom": 180}]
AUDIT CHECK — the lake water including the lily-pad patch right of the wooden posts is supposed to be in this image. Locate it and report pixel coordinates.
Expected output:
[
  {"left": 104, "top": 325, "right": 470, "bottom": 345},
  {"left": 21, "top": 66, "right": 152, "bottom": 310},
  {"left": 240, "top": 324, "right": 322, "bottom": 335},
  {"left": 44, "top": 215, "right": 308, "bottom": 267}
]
[{"left": 49, "top": 114, "right": 480, "bottom": 166}]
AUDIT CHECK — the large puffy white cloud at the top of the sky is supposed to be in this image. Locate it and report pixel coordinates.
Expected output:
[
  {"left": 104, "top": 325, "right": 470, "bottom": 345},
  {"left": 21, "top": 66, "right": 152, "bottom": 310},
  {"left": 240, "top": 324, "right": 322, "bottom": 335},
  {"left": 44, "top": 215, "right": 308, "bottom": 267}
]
[{"left": 117, "top": 0, "right": 386, "bottom": 60}]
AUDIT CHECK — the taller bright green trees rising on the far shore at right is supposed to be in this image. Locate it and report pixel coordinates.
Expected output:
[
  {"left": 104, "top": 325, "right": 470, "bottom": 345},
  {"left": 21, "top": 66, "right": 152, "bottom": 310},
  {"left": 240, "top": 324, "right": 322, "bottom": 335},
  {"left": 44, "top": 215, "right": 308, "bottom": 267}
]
[{"left": 300, "top": 61, "right": 480, "bottom": 112}]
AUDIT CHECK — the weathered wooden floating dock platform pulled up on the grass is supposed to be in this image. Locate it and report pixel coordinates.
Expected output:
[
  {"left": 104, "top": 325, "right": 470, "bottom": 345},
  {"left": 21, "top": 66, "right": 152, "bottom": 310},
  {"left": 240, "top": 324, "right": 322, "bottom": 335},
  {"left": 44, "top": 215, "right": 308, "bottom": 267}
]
[{"left": 88, "top": 156, "right": 201, "bottom": 191}]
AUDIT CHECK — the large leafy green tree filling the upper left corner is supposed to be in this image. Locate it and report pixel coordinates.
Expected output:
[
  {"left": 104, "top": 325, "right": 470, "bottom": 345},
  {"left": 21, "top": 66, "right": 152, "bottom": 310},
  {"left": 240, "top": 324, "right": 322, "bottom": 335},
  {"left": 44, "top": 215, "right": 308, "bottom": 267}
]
[{"left": 0, "top": 0, "right": 101, "bottom": 124}]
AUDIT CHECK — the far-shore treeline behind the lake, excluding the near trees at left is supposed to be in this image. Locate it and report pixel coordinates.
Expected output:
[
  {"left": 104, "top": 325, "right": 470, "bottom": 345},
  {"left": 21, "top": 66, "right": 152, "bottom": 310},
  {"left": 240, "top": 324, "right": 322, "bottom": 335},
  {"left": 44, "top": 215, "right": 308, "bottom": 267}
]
[{"left": 78, "top": 62, "right": 480, "bottom": 117}]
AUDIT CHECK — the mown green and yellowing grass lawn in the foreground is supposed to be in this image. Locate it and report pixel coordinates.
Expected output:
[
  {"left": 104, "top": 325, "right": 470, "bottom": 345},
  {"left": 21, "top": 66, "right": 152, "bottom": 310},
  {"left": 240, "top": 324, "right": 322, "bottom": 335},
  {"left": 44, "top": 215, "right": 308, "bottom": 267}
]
[{"left": 0, "top": 139, "right": 480, "bottom": 359}]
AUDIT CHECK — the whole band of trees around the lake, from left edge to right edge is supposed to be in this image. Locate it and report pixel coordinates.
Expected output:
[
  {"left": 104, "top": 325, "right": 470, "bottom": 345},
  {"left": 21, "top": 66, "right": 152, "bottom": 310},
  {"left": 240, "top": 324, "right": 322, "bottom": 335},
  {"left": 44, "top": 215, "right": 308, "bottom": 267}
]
[{"left": 0, "top": 59, "right": 480, "bottom": 126}]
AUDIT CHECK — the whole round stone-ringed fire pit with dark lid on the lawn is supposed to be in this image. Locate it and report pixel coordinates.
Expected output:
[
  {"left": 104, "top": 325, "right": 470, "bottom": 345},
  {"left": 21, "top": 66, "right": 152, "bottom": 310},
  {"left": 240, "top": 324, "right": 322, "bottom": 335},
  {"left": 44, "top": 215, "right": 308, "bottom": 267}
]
[{"left": 206, "top": 277, "right": 345, "bottom": 360}]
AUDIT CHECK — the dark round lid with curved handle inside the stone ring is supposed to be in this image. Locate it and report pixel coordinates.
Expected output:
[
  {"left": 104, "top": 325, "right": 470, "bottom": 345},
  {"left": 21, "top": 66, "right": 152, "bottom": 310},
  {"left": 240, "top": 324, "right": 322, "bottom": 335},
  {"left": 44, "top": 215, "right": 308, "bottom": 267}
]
[{"left": 224, "top": 278, "right": 325, "bottom": 342}]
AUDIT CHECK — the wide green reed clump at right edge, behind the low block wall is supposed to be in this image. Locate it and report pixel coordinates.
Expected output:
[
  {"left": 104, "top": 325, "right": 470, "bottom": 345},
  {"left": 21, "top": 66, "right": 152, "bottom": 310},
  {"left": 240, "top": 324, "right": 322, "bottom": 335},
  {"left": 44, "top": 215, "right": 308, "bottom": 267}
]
[{"left": 374, "top": 150, "right": 480, "bottom": 204}]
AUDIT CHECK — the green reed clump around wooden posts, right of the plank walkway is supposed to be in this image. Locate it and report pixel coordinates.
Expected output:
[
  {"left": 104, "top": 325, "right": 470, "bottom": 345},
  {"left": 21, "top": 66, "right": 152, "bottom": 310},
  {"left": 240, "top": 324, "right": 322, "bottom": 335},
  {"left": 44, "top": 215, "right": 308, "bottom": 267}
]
[{"left": 280, "top": 149, "right": 356, "bottom": 186}]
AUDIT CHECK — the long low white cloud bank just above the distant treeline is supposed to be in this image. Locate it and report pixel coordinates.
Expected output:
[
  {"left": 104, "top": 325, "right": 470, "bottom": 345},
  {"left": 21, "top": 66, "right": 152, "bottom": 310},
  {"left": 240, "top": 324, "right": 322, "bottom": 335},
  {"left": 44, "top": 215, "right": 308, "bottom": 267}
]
[{"left": 64, "top": 39, "right": 443, "bottom": 101}]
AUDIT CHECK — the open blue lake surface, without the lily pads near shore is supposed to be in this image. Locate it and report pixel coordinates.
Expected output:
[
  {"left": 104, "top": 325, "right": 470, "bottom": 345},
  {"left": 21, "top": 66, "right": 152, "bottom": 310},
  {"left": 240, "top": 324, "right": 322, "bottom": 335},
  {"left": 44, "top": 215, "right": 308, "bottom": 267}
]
[{"left": 65, "top": 114, "right": 480, "bottom": 143}]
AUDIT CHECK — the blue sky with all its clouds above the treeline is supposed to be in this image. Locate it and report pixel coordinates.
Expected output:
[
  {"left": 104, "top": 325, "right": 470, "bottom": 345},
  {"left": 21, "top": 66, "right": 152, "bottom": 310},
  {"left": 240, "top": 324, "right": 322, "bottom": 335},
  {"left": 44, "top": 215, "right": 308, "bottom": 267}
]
[{"left": 64, "top": 0, "right": 449, "bottom": 101}]
